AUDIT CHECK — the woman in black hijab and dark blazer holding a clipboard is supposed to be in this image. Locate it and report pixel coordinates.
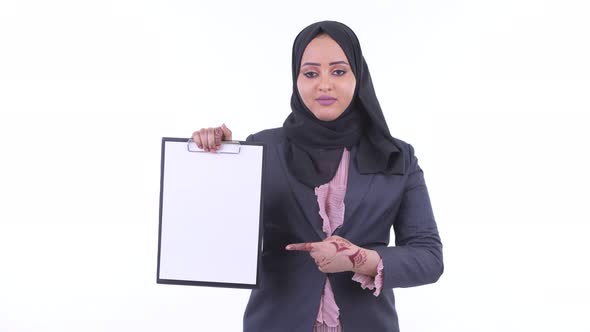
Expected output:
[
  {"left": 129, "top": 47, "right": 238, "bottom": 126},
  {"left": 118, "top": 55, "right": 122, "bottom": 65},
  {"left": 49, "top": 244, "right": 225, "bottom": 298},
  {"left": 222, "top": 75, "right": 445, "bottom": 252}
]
[{"left": 193, "top": 21, "right": 443, "bottom": 332}]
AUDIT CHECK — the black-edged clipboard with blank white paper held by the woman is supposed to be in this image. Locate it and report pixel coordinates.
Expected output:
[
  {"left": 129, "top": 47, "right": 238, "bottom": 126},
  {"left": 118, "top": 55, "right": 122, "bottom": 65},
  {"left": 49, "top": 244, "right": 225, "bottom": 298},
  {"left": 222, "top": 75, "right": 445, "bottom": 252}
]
[{"left": 157, "top": 137, "right": 264, "bottom": 289}]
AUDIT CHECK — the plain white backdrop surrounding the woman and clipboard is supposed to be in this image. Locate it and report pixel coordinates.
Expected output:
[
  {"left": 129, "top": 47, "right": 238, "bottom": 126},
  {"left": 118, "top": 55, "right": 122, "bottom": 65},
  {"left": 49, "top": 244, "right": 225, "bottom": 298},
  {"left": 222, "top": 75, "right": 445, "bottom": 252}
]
[{"left": 0, "top": 0, "right": 590, "bottom": 332}]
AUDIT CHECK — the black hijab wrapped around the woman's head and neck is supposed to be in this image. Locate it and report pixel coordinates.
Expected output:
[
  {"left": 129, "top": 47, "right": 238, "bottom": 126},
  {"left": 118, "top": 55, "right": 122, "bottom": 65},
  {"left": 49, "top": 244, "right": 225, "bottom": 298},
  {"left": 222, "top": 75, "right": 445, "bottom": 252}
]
[{"left": 283, "top": 21, "right": 404, "bottom": 188}]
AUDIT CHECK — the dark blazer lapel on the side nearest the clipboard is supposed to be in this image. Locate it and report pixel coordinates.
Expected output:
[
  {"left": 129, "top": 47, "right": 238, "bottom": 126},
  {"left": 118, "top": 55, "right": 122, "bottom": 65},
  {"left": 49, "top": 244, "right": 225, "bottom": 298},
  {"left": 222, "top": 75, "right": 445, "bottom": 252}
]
[{"left": 276, "top": 144, "right": 326, "bottom": 240}]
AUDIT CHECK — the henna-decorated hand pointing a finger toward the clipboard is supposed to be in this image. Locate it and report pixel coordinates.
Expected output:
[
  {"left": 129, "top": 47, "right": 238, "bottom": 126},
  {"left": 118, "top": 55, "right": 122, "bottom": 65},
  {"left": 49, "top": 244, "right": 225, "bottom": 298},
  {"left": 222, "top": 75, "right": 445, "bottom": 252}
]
[{"left": 286, "top": 235, "right": 380, "bottom": 275}]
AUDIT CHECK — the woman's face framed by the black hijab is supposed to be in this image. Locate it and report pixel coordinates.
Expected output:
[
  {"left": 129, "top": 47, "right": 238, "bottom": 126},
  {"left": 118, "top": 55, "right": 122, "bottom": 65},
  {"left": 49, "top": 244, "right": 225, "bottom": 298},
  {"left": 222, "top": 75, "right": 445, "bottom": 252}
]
[{"left": 297, "top": 35, "right": 356, "bottom": 121}]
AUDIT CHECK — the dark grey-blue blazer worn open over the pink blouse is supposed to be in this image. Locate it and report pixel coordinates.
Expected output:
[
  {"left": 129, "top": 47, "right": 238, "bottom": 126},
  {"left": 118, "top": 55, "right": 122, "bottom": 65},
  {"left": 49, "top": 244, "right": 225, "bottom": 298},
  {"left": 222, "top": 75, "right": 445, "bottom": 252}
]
[{"left": 244, "top": 128, "right": 443, "bottom": 332}]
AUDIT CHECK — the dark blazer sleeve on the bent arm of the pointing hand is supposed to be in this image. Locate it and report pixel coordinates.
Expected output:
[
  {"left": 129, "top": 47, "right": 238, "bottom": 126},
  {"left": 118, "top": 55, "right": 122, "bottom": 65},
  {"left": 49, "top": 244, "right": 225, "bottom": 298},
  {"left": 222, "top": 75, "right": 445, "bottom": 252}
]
[{"left": 372, "top": 145, "right": 444, "bottom": 289}]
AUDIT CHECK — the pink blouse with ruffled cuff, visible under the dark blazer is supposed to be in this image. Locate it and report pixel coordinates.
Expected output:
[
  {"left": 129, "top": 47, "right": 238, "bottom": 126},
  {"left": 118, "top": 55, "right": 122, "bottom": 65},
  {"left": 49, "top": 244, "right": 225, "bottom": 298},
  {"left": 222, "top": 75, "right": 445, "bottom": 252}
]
[{"left": 314, "top": 149, "right": 383, "bottom": 332}]
